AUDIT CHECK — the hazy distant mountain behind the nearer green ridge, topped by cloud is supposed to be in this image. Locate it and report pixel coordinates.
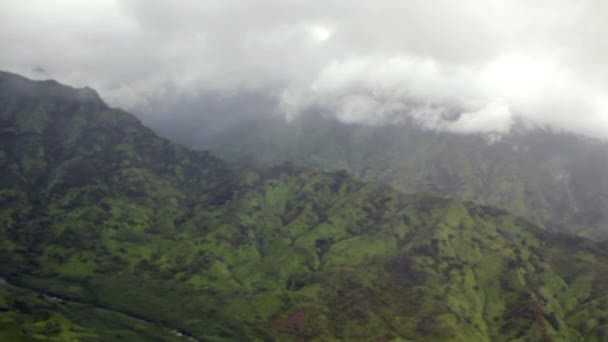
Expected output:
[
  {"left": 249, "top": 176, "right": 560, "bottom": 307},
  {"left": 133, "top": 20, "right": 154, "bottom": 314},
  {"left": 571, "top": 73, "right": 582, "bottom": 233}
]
[{"left": 155, "top": 109, "right": 608, "bottom": 240}]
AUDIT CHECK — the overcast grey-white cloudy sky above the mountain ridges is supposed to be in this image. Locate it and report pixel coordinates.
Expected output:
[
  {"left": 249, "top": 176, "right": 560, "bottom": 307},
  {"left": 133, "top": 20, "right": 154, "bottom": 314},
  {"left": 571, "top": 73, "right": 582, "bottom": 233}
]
[{"left": 0, "top": 0, "right": 608, "bottom": 139}]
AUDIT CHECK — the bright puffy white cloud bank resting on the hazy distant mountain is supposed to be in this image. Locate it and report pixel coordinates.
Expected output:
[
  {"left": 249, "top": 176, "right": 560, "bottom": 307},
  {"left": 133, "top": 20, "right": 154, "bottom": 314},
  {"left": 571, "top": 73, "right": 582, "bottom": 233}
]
[{"left": 282, "top": 55, "right": 592, "bottom": 136}]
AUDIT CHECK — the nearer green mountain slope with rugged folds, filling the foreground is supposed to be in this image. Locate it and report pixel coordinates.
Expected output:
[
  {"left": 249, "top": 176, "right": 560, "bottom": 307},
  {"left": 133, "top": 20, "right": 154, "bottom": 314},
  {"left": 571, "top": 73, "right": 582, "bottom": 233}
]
[{"left": 0, "top": 73, "right": 608, "bottom": 341}]
